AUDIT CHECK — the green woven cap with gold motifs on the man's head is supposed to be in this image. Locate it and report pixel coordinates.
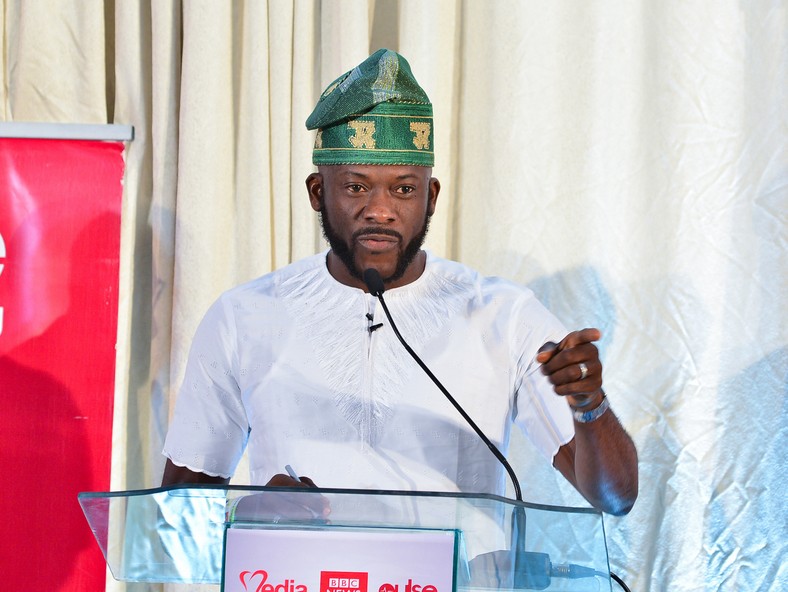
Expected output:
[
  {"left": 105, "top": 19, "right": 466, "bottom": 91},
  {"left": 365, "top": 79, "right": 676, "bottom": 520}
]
[{"left": 306, "top": 49, "right": 435, "bottom": 166}]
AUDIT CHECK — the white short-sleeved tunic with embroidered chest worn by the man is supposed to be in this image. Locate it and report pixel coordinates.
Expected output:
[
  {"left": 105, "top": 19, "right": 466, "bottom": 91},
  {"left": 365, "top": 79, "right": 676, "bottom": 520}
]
[{"left": 164, "top": 253, "right": 574, "bottom": 494}]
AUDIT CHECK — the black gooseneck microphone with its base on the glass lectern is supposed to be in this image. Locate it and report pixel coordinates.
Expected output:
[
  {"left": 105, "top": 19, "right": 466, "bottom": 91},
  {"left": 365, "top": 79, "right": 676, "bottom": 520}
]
[{"left": 363, "top": 268, "right": 607, "bottom": 590}]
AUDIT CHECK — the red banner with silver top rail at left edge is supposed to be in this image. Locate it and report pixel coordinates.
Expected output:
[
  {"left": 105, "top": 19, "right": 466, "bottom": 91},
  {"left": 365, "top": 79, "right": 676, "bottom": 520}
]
[{"left": 0, "top": 138, "right": 123, "bottom": 592}]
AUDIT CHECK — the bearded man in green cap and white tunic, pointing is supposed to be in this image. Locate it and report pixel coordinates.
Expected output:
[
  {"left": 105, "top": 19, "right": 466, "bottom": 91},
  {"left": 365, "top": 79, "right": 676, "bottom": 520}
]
[{"left": 163, "top": 50, "right": 637, "bottom": 514}]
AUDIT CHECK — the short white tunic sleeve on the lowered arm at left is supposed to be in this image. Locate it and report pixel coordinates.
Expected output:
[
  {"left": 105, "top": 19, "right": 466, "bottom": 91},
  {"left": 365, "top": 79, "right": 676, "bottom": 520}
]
[{"left": 163, "top": 297, "right": 249, "bottom": 478}]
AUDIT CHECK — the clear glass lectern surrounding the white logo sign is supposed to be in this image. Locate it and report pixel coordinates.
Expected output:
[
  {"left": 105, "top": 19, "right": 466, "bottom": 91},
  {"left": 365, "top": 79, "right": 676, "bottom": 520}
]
[{"left": 79, "top": 485, "right": 611, "bottom": 592}]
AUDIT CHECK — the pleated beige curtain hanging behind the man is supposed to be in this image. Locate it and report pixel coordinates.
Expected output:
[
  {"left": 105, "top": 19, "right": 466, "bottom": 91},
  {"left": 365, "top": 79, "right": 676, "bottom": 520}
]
[{"left": 0, "top": 0, "right": 788, "bottom": 591}]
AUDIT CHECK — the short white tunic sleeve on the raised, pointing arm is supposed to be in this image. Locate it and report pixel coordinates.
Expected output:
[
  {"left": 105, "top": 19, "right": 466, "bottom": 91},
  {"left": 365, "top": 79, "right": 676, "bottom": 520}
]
[{"left": 512, "top": 294, "right": 575, "bottom": 462}]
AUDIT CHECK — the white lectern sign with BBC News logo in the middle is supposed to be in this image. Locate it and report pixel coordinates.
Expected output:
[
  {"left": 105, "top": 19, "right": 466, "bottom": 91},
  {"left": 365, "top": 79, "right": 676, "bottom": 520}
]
[{"left": 222, "top": 527, "right": 457, "bottom": 592}]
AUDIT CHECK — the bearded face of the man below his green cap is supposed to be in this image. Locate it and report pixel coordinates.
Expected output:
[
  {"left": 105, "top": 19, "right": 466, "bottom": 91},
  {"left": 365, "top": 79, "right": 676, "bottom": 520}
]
[{"left": 307, "top": 165, "right": 440, "bottom": 289}]
